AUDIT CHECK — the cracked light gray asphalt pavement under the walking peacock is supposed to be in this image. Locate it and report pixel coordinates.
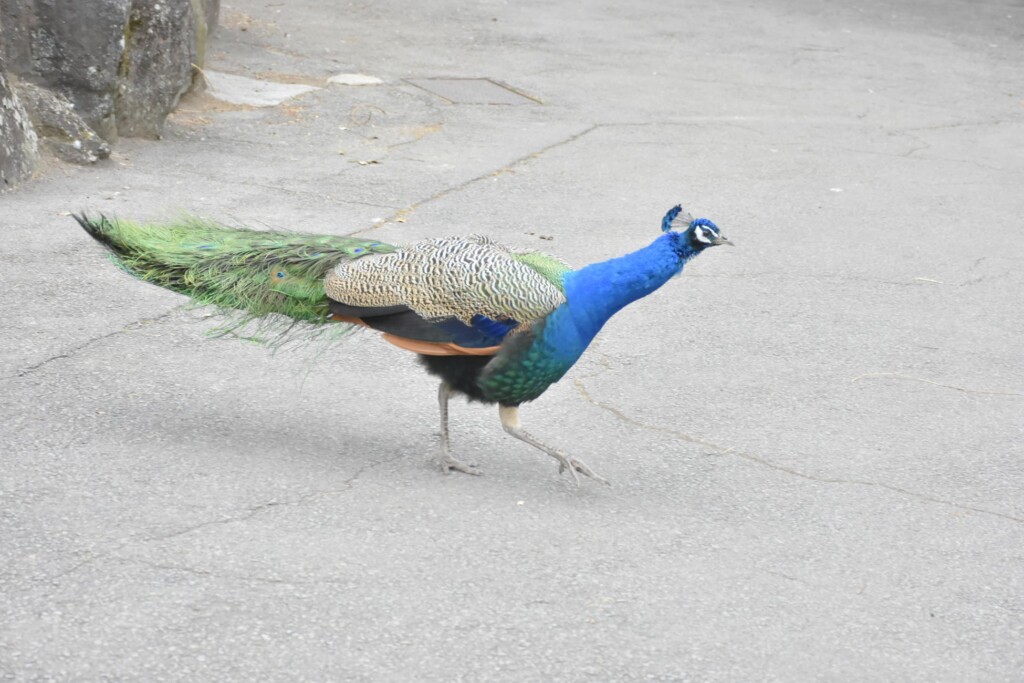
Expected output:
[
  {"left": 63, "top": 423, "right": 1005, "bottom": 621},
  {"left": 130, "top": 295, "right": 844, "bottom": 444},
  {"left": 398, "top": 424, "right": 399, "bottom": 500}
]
[{"left": 0, "top": 0, "right": 1024, "bottom": 681}]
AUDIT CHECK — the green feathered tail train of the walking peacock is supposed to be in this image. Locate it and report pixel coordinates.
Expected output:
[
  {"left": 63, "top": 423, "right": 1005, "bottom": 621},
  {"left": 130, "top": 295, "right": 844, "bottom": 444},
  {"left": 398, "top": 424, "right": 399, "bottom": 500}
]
[{"left": 75, "top": 215, "right": 395, "bottom": 339}]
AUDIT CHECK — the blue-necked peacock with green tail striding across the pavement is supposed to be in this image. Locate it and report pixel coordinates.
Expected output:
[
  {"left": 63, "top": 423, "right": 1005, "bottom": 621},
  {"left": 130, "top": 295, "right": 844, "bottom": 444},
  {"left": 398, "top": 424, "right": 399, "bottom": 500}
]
[{"left": 75, "top": 205, "right": 732, "bottom": 484}]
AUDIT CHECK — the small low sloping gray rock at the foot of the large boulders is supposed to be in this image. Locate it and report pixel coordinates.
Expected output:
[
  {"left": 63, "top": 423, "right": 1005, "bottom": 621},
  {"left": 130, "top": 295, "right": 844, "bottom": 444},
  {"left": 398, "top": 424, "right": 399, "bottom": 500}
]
[{"left": 15, "top": 83, "right": 111, "bottom": 164}]
